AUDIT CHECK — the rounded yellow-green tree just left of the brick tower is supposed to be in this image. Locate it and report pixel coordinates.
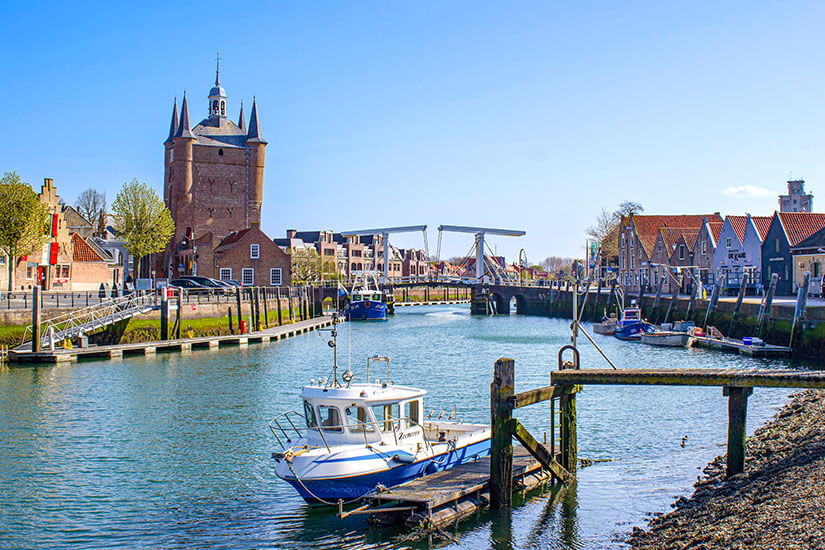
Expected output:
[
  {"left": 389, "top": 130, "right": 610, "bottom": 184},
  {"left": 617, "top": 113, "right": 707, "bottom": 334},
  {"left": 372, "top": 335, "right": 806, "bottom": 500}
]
[{"left": 112, "top": 178, "right": 175, "bottom": 275}]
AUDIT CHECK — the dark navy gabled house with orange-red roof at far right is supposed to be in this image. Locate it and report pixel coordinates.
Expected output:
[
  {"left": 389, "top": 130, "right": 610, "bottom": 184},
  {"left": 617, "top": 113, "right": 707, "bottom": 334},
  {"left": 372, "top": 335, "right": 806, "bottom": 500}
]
[{"left": 762, "top": 212, "right": 825, "bottom": 296}]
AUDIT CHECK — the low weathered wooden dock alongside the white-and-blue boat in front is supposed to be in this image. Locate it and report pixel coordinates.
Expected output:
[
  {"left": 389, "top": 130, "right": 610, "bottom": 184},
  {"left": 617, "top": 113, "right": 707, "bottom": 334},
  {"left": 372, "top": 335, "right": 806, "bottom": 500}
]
[{"left": 338, "top": 446, "right": 550, "bottom": 528}]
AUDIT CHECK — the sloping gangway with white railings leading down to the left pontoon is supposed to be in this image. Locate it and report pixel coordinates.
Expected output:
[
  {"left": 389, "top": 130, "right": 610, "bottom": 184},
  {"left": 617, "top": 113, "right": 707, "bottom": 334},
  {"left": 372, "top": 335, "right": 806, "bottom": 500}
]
[{"left": 15, "top": 293, "right": 160, "bottom": 350}]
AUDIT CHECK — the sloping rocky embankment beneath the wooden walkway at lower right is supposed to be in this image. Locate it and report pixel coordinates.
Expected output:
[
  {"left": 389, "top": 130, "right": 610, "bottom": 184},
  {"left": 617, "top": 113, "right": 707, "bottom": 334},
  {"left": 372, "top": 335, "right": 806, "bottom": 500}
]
[{"left": 627, "top": 390, "right": 825, "bottom": 550}]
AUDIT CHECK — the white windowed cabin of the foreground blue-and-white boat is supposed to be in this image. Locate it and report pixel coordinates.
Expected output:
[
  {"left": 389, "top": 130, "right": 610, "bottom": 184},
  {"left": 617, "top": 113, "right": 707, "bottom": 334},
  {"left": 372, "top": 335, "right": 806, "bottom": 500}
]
[{"left": 301, "top": 384, "right": 427, "bottom": 447}]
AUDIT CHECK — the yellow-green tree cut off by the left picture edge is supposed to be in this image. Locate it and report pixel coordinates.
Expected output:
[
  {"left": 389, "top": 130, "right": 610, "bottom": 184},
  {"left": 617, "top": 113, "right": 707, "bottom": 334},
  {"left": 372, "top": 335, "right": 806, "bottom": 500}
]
[{"left": 0, "top": 172, "right": 49, "bottom": 291}]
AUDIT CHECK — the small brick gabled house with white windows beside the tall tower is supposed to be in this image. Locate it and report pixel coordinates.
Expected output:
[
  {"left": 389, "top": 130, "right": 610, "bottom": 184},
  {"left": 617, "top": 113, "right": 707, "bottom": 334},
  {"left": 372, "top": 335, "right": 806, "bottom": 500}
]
[{"left": 212, "top": 224, "right": 291, "bottom": 286}]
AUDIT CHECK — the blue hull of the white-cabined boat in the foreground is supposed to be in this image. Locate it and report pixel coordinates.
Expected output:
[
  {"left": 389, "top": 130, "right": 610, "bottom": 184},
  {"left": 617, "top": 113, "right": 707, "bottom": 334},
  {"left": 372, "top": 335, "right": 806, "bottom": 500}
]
[{"left": 286, "top": 439, "right": 490, "bottom": 504}]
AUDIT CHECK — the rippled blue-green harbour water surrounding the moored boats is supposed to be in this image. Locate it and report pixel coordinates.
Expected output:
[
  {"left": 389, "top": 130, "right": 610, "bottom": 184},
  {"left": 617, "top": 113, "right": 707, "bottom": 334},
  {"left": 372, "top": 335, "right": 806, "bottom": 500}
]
[{"left": 0, "top": 305, "right": 800, "bottom": 548}]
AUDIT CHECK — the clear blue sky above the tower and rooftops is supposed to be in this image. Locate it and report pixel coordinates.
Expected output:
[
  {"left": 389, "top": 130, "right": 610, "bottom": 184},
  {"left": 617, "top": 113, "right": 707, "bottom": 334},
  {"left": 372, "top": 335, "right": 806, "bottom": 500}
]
[{"left": 0, "top": 1, "right": 825, "bottom": 261}]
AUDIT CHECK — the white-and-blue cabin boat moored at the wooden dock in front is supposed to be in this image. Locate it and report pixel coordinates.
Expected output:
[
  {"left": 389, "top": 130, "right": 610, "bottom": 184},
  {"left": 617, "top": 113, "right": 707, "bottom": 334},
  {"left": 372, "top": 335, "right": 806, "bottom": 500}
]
[{"left": 269, "top": 318, "right": 490, "bottom": 505}]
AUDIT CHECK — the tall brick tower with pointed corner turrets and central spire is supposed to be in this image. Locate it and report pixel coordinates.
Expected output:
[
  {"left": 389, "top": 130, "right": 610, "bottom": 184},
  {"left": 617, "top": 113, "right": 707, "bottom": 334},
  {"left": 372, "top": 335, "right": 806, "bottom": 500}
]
[{"left": 165, "top": 60, "right": 267, "bottom": 277}]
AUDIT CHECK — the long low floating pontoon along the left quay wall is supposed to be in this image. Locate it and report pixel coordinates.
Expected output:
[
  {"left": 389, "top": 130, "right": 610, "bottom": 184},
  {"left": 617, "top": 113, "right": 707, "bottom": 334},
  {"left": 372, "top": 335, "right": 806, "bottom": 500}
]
[{"left": 8, "top": 316, "right": 332, "bottom": 363}]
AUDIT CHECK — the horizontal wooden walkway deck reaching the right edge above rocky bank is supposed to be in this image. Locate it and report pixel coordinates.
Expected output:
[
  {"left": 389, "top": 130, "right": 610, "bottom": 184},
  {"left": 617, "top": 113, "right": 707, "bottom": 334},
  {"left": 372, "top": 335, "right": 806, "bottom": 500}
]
[{"left": 550, "top": 369, "right": 825, "bottom": 388}]
